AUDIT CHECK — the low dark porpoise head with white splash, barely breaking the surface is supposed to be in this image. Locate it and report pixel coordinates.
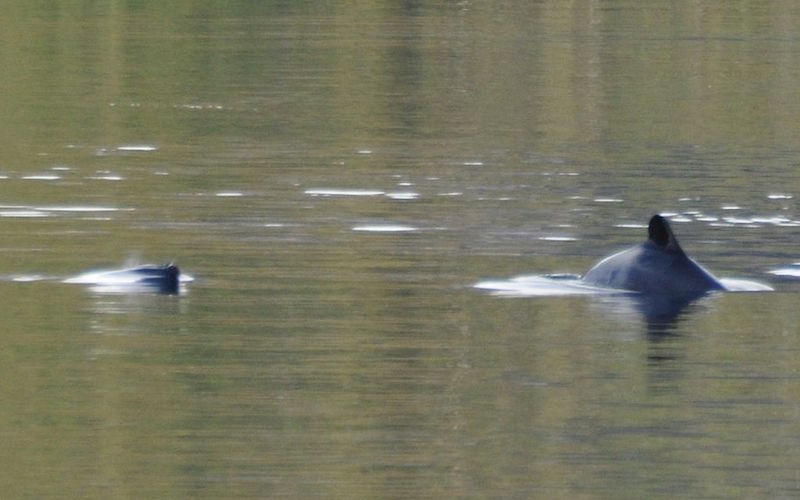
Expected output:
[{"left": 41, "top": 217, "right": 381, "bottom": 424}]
[{"left": 64, "top": 263, "right": 181, "bottom": 294}]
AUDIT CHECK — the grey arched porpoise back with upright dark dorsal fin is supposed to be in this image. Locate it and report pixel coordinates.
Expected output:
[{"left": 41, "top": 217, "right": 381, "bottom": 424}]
[{"left": 583, "top": 215, "right": 725, "bottom": 296}]
